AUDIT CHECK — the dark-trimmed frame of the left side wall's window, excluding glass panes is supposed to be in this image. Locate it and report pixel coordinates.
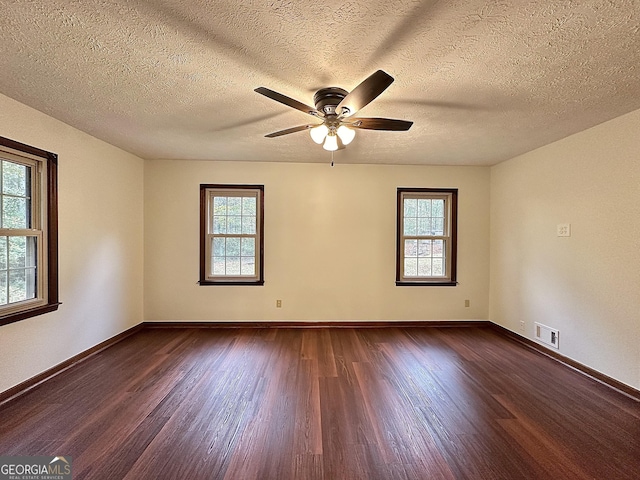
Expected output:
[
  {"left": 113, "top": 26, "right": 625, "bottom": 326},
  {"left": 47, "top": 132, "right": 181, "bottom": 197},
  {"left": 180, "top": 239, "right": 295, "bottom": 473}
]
[{"left": 0, "top": 137, "right": 59, "bottom": 325}]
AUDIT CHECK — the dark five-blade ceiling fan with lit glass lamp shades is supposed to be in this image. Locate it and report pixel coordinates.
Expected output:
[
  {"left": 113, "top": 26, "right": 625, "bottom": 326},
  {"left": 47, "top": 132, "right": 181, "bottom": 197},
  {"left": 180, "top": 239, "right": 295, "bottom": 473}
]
[{"left": 255, "top": 70, "right": 413, "bottom": 151}]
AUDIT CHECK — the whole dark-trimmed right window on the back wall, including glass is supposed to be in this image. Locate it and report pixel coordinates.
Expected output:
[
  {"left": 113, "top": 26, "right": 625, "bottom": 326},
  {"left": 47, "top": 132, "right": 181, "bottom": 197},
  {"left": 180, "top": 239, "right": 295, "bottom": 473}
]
[{"left": 396, "top": 188, "right": 458, "bottom": 286}]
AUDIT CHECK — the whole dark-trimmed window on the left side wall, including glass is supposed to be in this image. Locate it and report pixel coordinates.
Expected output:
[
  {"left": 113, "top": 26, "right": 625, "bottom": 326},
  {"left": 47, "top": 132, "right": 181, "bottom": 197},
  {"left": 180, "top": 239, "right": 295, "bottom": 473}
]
[{"left": 0, "top": 137, "right": 58, "bottom": 325}]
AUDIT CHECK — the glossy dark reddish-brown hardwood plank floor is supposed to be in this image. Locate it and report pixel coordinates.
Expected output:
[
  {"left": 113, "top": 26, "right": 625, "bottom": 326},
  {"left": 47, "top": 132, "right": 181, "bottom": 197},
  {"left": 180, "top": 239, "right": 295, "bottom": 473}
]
[{"left": 0, "top": 327, "right": 640, "bottom": 480}]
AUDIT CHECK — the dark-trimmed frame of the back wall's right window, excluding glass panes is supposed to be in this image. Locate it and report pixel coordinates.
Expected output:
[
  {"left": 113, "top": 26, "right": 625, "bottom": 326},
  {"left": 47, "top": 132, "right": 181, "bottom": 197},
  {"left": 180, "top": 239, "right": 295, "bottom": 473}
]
[{"left": 396, "top": 188, "right": 458, "bottom": 286}]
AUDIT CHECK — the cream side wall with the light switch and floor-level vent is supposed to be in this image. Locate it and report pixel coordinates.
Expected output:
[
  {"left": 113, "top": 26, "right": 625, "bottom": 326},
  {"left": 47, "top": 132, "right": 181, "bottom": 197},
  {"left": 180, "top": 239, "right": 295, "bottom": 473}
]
[{"left": 490, "top": 110, "right": 640, "bottom": 388}]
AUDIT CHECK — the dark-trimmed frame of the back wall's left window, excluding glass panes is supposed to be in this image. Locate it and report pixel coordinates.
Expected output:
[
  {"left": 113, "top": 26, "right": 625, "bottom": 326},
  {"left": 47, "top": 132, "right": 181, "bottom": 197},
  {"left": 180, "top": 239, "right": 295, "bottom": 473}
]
[{"left": 199, "top": 184, "right": 264, "bottom": 285}]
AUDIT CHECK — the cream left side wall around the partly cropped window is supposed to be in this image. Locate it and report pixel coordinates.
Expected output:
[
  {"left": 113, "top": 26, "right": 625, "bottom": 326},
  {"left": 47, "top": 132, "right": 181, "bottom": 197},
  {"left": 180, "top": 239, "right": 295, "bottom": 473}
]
[{"left": 0, "top": 95, "right": 144, "bottom": 392}]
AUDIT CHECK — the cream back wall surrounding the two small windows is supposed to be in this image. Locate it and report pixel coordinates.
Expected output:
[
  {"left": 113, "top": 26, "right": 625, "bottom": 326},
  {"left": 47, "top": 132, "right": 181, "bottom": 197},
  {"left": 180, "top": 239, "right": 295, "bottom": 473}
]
[{"left": 145, "top": 161, "right": 489, "bottom": 321}]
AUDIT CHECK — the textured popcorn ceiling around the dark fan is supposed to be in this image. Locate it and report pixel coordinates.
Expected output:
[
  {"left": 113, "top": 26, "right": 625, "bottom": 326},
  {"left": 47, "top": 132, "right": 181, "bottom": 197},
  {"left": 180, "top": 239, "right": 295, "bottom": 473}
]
[{"left": 0, "top": 0, "right": 640, "bottom": 165}]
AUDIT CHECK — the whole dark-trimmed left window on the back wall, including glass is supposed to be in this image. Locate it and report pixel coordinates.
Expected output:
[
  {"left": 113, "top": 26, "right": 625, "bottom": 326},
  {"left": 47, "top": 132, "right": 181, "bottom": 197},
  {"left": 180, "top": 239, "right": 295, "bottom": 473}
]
[{"left": 200, "top": 185, "right": 264, "bottom": 285}]
